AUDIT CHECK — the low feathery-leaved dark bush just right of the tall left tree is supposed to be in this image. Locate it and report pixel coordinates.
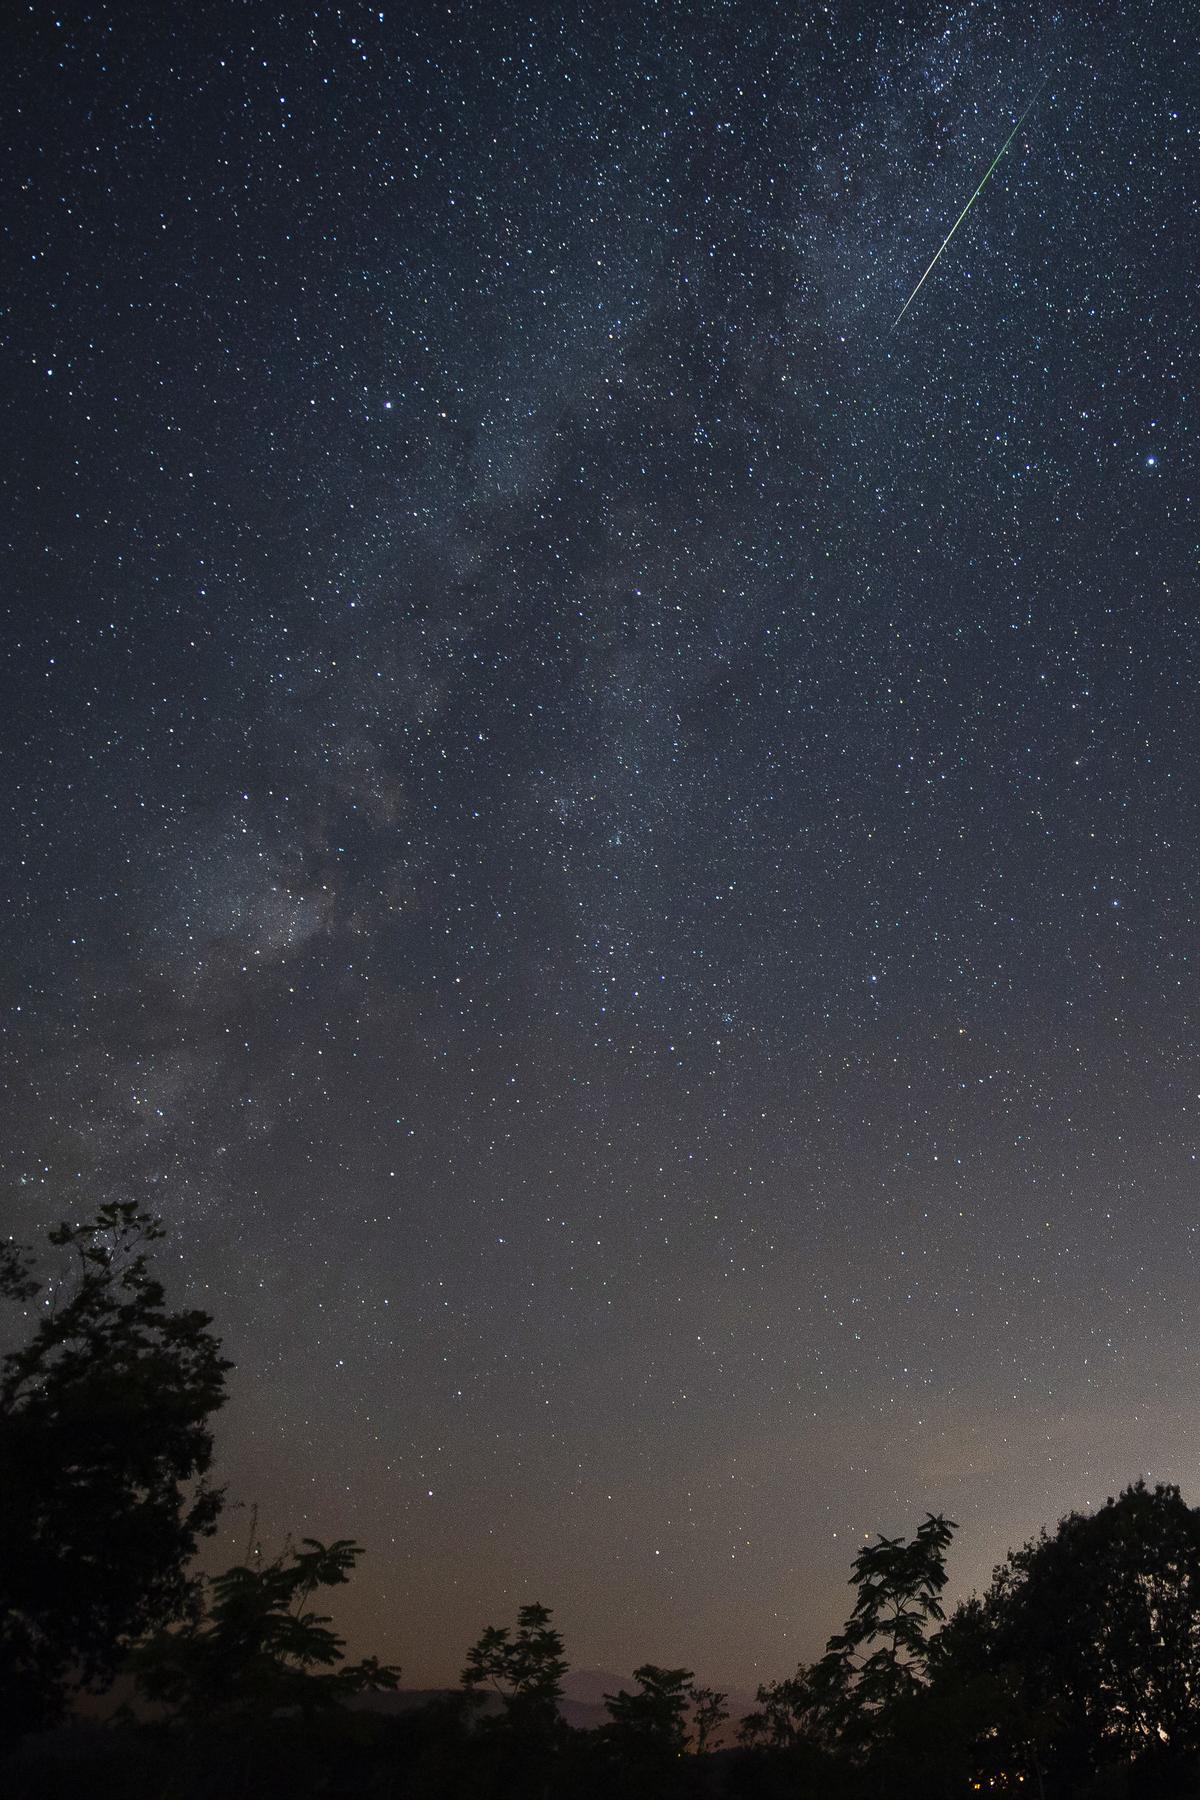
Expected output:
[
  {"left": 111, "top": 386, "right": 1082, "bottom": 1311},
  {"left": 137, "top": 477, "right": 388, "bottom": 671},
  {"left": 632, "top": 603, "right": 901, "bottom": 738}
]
[{"left": 131, "top": 1537, "right": 399, "bottom": 1724}]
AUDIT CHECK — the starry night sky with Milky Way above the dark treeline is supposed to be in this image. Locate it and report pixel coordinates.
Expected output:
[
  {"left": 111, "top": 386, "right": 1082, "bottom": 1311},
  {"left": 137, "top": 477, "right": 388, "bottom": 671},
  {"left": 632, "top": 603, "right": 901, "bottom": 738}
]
[{"left": 0, "top": 0, "right": 1200, "bottom": 1688}]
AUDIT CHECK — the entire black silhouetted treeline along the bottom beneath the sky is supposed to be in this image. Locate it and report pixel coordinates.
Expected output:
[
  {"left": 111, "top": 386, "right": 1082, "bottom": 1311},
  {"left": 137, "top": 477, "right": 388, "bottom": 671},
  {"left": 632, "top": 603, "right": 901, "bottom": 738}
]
[{"left": 0, "top": 1204, "right": 1200, "bottom": 1800}]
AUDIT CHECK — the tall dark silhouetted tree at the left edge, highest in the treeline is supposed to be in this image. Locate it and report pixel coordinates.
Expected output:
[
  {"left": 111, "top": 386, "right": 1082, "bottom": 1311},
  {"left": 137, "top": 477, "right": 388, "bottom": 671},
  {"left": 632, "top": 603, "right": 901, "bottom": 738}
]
[{"left": 0, "top": 1202, "right": 230, "bottom": 1741}]
